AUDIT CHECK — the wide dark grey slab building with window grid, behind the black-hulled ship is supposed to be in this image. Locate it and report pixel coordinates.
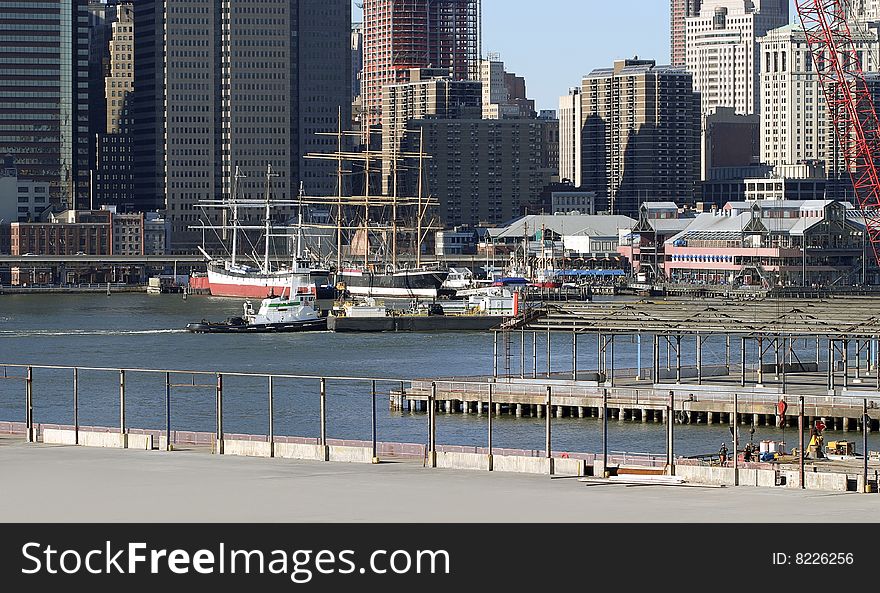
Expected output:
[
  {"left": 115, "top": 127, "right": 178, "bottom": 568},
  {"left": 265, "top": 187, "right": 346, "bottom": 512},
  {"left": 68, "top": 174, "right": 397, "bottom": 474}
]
[{"left": 403, "top": 118, "right": 556, "bottom": 227}]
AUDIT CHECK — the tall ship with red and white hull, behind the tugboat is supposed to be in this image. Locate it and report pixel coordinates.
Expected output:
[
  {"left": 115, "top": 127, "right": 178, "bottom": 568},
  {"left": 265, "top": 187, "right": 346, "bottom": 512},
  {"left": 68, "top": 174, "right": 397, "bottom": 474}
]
[{"left": 200, "top": 165, "right": 335, "bottom": 299}]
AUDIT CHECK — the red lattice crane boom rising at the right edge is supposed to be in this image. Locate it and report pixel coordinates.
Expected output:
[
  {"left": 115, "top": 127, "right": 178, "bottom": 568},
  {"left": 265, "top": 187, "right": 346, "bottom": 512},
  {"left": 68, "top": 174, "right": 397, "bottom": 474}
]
[{"left": 795, "top": 0, "right": 880, "bottom": 261}]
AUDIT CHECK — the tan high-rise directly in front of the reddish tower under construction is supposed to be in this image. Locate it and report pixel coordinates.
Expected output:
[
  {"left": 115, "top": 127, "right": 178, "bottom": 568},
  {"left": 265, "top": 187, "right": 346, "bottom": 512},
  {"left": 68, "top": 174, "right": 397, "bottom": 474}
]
[{"left": 382, "top": 68, "right": 482, "bottom": 194}]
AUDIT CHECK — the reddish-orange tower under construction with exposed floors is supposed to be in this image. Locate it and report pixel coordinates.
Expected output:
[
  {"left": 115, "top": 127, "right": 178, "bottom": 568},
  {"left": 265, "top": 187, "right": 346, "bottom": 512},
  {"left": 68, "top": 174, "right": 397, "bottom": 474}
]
[{"left": 362, "top": 0, "right": 480, "bottom": 126}]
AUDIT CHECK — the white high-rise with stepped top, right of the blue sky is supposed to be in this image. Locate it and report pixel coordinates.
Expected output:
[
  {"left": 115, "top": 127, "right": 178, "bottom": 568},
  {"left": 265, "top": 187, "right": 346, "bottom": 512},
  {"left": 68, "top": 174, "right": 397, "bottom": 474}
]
[{"left": 685, "top": 0, "right": 789, "bottom": 115}]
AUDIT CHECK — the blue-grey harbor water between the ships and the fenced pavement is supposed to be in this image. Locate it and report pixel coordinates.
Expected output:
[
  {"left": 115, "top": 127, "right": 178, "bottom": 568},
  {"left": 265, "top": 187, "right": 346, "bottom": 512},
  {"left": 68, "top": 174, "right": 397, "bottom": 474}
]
[{"left": 0, "top": 294, "right": 880, "bottom": 456}]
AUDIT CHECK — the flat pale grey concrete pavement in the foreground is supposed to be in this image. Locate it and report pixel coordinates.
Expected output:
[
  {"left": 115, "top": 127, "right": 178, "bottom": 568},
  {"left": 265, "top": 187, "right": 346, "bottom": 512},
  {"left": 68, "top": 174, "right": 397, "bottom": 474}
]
[{"left": 0, "top": 437, "right": 880, "bottom": 523}]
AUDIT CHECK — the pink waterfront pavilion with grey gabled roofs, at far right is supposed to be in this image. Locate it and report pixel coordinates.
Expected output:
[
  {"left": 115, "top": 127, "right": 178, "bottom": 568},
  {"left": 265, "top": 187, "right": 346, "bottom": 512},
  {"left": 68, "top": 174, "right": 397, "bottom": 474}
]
[{"left": 665, "top": 200, "right": 870, "bottom": 288}]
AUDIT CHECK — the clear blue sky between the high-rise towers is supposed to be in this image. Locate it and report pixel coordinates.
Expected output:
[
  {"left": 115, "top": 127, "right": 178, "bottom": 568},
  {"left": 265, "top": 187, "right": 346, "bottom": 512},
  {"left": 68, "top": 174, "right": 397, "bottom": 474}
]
[{"left": 352, "top": 0, "right": 796, "bottom": 109}]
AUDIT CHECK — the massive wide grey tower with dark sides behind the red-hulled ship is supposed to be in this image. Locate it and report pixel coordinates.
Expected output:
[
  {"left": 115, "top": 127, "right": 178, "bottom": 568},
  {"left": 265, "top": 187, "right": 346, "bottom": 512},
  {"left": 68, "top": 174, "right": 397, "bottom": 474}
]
[{"left": 133, "top": 0, "right": 351, "bottom": 251}]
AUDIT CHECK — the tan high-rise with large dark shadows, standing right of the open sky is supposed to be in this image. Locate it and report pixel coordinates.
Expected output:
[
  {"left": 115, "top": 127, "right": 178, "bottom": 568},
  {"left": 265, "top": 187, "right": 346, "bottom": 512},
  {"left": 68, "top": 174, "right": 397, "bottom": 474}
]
[{"left": 581, "top": 60, "right": 700, "bottom": 216}]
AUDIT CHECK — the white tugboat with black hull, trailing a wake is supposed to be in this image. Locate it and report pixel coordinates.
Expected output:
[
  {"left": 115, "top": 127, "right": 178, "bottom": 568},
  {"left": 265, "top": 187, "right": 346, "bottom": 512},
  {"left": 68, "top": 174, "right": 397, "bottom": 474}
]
[{"left": 186, "top": 294, "right": 327, "bottom": 334}]
